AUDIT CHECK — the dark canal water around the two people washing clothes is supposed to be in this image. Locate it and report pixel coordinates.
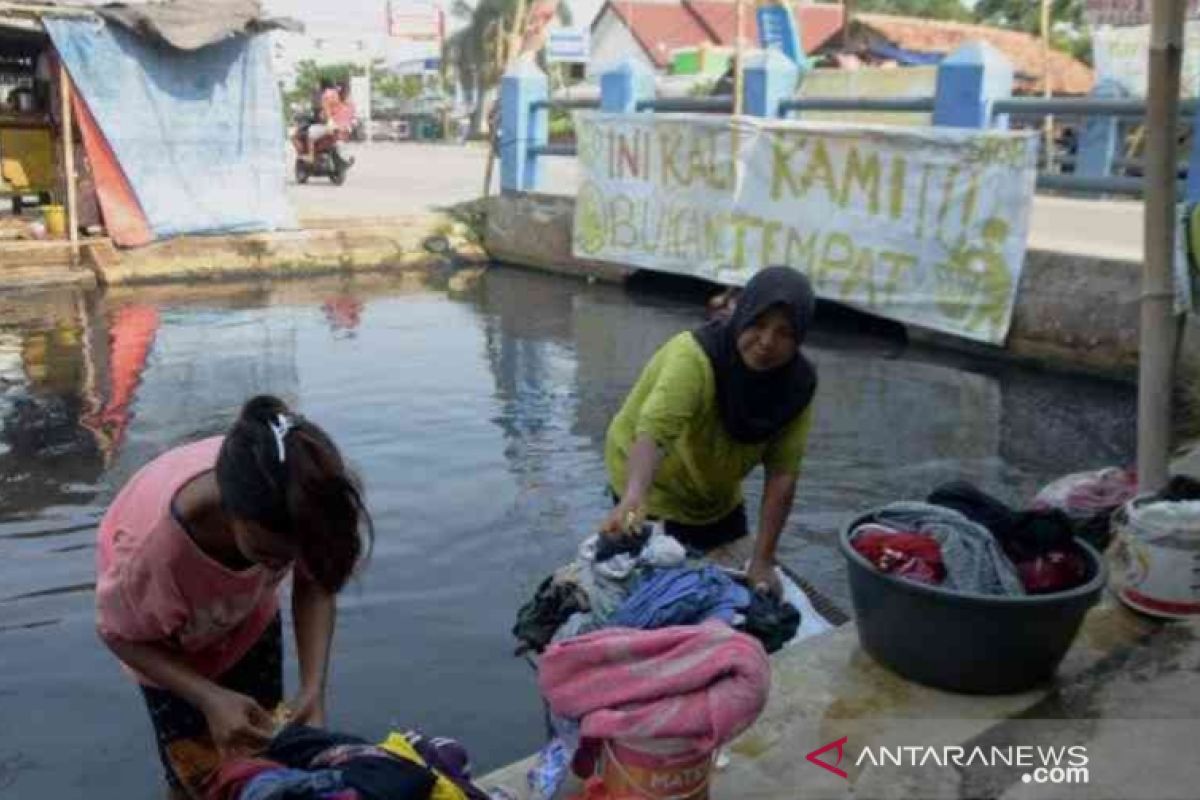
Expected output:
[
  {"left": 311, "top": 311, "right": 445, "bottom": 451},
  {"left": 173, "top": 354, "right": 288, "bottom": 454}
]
[{"left": 0, "top": 269, "right": 1134, "bottom": 800}]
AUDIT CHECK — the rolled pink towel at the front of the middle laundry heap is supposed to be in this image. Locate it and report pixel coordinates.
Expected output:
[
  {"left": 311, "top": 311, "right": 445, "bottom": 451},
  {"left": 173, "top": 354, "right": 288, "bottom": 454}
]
[{"left": 538, "top": 622, "right": 770, "bottom": 756}]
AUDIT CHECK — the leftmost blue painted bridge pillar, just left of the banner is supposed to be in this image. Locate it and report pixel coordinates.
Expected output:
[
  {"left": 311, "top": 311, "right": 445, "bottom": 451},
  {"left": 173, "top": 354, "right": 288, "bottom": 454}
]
[{"left": 500, "top": 60, "right": 550, "bottom": 192}]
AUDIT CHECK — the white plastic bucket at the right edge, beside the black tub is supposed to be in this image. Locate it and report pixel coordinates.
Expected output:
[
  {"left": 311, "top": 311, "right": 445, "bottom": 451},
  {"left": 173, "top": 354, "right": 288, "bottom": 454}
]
[{"left": 1112, "top": 498, "right": 1200, "bottom": 619}]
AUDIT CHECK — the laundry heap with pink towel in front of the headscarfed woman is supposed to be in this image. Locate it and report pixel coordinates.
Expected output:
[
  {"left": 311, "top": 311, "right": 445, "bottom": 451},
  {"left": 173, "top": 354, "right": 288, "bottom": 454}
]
[{"left": 512, "top": 525, "right": 801, "bottom": 800}]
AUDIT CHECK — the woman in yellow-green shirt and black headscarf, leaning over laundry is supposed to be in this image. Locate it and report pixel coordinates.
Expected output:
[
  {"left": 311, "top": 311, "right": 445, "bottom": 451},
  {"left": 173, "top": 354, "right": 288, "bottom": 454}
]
[{"left": 601, "top": 266, "right": 817, "bottom": 593}]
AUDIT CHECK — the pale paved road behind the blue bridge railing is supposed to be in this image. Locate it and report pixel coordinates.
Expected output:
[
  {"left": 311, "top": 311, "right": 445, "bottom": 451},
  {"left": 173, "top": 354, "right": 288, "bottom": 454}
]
[{"left": 290, "top": 143, "right": 1142, "bottom": 260}]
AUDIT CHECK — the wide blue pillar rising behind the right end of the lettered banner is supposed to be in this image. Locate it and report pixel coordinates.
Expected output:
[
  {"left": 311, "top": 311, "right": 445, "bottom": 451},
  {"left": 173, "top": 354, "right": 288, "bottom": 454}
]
[{"left": 934, "top": 42, "right": 1013, "bottom": 128}]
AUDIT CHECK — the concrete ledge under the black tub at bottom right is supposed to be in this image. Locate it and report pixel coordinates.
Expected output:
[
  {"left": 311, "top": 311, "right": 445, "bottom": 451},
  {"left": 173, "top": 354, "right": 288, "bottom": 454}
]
[{"left": 481, "top": 599, "right": 1200, "bottom": 800}]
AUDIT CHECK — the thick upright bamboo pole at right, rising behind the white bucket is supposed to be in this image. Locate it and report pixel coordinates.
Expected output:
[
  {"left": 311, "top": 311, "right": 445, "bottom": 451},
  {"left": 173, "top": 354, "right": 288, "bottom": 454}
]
[{"left": 1138, "top": 0, "right": 1187, "bottom": 492}]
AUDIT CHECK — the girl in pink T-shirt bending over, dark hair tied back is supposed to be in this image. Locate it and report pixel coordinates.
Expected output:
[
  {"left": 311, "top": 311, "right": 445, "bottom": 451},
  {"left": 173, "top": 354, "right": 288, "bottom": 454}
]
[{"left": 96, "top": 396, "right": 372, "bottom": 798}]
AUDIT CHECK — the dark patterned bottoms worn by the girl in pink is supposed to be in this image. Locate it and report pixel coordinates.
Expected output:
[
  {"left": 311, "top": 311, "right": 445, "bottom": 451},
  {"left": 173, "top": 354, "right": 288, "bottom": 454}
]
[{"left": 142, "top": 616, "right": 283, "bottom": 796}]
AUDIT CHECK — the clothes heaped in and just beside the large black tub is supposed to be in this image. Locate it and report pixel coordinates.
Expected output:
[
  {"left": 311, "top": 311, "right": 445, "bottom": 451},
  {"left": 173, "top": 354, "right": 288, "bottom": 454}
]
[{"left": 851, "top": 479, "right": 1133, "bottom": 596}]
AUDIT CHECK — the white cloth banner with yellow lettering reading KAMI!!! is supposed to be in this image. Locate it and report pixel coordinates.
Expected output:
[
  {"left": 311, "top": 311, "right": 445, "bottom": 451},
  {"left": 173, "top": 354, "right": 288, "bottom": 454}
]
[{"left": 572, "top": 112, "right": 1037, "bottom": 344}]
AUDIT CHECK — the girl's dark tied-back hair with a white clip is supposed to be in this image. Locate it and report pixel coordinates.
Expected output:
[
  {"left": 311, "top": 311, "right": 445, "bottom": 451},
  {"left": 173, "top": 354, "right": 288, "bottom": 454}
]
[{"left": 216, "top": 395, "right": 374, "bottom": 593}]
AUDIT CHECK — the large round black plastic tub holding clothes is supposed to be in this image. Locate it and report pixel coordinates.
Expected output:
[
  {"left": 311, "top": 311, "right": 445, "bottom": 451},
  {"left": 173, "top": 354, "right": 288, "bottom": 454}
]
[{"left": 840, "top": 515, "right": 1108, "bottom": 694}]
